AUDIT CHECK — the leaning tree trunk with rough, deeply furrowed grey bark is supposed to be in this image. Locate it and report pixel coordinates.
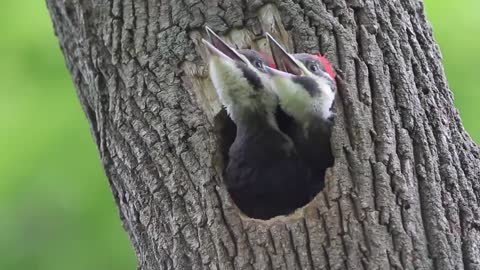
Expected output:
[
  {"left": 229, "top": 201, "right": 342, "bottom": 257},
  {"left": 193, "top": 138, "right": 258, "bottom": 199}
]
[{"left": 47, "top": 0, "right": 480, "bottom": 269}]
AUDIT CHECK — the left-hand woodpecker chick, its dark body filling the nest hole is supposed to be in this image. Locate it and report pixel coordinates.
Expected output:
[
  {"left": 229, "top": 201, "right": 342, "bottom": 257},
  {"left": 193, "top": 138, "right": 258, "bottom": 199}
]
[{"left": 203, "top": 28, "right": 311, "bottom": 219}]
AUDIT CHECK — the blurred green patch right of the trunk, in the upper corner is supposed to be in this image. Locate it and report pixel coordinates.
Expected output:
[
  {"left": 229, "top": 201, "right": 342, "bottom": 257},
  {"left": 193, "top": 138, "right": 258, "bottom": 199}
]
[{"left": 424, "top": 0, "right": 480, "bottom": 144}]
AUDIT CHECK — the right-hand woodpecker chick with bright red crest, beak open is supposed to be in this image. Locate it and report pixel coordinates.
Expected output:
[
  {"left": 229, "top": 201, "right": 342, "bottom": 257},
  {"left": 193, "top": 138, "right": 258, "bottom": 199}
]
[{"left": 267, "top": 34, "right": 336, "bottom": 196}]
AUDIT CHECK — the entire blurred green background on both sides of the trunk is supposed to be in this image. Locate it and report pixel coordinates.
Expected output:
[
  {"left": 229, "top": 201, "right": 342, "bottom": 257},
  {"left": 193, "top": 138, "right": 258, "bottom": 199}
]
[{"left": 0, "top": 0, "right": 480, "bottom": 270}]
